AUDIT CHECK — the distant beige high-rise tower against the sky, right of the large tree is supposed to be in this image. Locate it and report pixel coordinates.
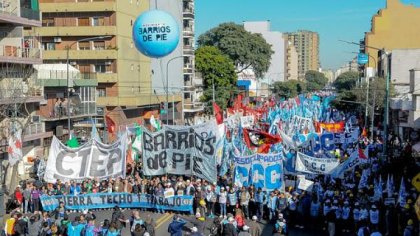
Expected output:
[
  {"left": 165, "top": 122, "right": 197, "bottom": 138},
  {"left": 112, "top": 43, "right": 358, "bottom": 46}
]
[{"left": 287, "top": 30, "right": 320, "bottom": 80}]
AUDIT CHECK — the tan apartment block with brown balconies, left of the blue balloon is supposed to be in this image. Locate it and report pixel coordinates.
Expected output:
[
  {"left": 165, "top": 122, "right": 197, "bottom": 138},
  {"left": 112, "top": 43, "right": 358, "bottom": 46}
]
[{"left": 26, "top": 0, "right": 159, "bottom": 140}]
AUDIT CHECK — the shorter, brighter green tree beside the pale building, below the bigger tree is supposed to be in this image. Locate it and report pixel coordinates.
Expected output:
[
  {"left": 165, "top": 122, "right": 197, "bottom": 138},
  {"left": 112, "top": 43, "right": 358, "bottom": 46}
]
[{"left": 195, "top": 46, "right": 237, "bottom": 112}]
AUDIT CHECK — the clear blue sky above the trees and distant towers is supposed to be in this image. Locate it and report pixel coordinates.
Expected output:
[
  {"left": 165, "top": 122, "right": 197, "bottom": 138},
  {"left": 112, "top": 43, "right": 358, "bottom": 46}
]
[{"left": 195, "top": 0, "right": 420, "bottom": 70}]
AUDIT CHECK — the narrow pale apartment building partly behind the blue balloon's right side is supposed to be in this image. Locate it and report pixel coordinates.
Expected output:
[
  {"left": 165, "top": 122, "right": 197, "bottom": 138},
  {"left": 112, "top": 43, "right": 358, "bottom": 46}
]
[{"left": 150, "top": 0, "right": 204, "bottom": 124}]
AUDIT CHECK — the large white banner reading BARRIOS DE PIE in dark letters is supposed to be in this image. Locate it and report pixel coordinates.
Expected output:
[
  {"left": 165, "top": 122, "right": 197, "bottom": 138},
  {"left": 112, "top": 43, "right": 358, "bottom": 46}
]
[{"left": 142, "top": 120, "right": 220, "bottom": 182}]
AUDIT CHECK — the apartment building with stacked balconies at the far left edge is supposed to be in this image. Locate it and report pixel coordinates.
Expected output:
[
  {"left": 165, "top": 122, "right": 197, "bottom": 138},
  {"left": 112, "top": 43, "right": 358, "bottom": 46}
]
[{"left": 0, "top": 0, "right": 47, "bottom": 187}]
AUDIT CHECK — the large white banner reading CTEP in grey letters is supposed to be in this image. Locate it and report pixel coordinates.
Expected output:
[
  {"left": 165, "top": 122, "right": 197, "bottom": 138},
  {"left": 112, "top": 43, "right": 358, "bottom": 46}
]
[{"left": 44, "top": 133, "right": 127, "bottom": 183}]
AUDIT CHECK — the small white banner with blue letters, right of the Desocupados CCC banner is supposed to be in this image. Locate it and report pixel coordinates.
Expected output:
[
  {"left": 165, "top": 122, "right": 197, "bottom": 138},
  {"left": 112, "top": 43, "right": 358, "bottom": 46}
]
[{"left": 296, "top": 152, "right": 340, "bottom": 175}]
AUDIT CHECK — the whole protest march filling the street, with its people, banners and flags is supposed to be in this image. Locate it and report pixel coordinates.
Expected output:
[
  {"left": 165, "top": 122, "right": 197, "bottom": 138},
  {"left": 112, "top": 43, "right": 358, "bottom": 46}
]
[{"left": 1, "top": 92, "right": 420, "bottom": 236}]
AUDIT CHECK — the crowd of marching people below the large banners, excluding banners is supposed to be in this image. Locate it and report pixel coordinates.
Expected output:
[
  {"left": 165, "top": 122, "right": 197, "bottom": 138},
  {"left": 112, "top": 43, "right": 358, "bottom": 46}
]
[{"left": 5, "top": 140, "right": 419, "bottom": 236}]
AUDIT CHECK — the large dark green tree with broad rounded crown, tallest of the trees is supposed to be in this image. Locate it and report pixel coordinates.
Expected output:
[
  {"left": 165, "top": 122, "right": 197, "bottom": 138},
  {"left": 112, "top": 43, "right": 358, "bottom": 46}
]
[{"left": 197, "top": 23, "right": 274, "bottom": 78}]
